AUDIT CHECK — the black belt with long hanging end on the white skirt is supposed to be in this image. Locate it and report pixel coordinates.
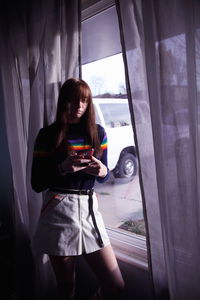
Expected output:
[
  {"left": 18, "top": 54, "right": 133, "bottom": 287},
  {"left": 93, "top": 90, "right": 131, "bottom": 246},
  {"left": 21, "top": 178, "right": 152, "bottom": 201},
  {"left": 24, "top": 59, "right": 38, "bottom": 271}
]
[{"left": 50, "top": 188, "right": 104, "bottom": 247}]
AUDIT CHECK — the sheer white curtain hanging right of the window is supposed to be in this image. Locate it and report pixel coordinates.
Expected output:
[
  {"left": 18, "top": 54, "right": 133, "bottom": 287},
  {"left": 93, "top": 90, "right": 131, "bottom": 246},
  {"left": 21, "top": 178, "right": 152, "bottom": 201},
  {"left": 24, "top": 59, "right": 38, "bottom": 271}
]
[{"left": 116, "top": 0, "right": 200, "bottom": 300}]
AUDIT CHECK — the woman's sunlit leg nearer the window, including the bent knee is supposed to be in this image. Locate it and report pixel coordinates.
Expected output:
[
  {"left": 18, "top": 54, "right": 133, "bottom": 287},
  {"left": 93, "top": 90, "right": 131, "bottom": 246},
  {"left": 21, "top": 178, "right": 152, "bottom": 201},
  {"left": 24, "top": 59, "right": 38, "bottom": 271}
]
[{"left": 85, "top": 245, "right": 124, "bottom": 300}]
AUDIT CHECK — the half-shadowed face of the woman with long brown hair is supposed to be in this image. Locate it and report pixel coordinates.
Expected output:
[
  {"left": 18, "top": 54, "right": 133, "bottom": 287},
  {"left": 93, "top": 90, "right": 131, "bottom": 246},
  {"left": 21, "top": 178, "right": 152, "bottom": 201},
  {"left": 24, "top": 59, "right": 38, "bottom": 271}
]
[{"left": 68, "top": 97, "right": 88, "bottom": 123}]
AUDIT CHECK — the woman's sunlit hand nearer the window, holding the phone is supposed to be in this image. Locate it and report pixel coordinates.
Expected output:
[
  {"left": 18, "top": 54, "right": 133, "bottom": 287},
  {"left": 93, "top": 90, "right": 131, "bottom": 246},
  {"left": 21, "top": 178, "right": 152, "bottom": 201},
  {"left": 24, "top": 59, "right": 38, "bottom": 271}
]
[{"left": 83, "top": 156, "right": 108, "bottom": 177}]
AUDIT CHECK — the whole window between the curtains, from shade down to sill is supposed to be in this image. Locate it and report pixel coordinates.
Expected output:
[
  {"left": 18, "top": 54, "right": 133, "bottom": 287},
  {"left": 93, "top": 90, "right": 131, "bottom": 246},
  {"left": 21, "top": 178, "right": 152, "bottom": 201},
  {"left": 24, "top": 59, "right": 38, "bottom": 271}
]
[{"left": 82, "top": 1, "right": 147, "bottom": 267}]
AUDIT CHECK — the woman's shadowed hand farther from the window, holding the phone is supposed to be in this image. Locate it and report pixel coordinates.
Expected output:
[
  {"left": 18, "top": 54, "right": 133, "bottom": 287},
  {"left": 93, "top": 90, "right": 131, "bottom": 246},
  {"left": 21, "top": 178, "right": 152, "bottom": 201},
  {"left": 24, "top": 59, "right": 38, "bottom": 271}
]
[{"left": 58, "top": 154, "right": 91, "bottom": 176}]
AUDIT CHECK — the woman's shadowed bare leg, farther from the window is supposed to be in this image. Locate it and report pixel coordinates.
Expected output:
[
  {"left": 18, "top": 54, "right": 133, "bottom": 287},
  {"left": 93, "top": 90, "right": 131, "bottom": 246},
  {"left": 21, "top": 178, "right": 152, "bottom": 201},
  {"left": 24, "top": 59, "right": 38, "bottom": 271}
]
[{"left": 49, "top": 255, "right": 76, "bottom": 300}]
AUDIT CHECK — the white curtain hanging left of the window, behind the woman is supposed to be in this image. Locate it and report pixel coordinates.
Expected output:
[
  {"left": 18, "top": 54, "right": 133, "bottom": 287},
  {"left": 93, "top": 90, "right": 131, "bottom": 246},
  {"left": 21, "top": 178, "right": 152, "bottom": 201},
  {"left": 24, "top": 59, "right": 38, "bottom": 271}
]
[{"left": 0, "top": 0, "right": 80, "bottom": 300}]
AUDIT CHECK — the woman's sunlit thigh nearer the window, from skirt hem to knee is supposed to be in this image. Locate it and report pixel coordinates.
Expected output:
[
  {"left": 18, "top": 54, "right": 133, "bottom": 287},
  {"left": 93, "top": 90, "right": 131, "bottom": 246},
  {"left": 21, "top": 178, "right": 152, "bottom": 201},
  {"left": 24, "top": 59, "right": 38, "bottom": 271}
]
[{"left": 84, "top": 245, "right": 124, "bottom": 290}]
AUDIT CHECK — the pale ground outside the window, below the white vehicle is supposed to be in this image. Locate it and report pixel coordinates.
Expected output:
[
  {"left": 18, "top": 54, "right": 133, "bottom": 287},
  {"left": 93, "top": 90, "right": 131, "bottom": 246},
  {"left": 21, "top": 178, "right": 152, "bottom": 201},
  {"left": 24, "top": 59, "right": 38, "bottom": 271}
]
[{"left": 95, "top": 173, "right": 145, "bottom": 235}]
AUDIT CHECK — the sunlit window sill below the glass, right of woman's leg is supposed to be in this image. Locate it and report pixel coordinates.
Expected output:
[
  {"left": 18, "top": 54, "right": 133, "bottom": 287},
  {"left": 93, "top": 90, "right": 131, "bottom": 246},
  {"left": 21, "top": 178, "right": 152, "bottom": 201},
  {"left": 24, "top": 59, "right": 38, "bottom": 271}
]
[{"left": 106, "top": 228, "right": 148, "bottom": 270}]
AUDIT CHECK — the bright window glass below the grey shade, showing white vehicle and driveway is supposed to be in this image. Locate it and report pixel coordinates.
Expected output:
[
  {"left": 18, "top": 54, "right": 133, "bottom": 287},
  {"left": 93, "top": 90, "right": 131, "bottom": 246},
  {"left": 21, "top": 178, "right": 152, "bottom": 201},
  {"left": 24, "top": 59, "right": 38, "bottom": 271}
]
[{"left": 82, "top": 5, "right": 146, "bottom": 235}]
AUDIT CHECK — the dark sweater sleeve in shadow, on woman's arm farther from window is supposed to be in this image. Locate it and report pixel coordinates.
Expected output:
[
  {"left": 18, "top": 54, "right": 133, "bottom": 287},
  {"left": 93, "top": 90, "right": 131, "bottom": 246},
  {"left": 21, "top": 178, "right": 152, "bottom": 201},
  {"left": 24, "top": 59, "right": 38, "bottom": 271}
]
[{"left": 31, "top": 128, "right": 58, "bottom": 193}]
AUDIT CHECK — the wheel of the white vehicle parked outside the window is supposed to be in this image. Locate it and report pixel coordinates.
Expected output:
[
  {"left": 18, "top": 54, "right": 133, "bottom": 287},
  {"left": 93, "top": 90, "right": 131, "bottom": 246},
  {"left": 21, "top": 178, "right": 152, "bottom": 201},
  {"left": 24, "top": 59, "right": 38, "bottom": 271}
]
[{"left": 115, "top": 153, "right": 137, "bottom": 178}]
